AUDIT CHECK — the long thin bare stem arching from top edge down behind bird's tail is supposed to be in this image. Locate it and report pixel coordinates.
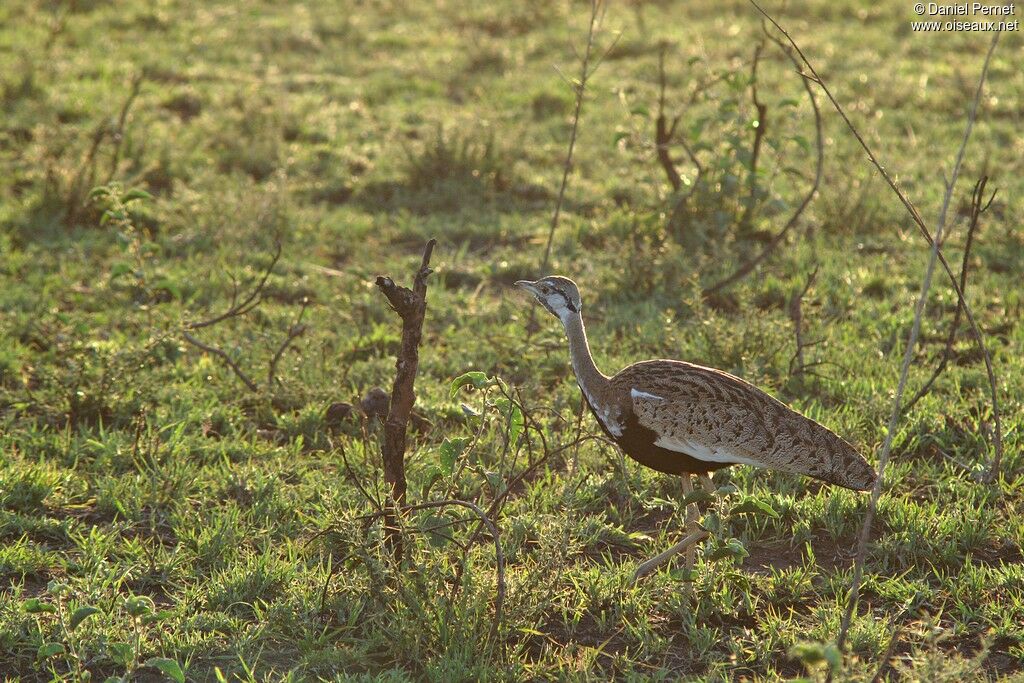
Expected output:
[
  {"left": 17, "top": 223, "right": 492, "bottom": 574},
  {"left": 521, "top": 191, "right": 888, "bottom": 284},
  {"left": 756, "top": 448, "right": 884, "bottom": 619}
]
[{"left": 749, "top": 0, "right": 1002, "bottom": 482}]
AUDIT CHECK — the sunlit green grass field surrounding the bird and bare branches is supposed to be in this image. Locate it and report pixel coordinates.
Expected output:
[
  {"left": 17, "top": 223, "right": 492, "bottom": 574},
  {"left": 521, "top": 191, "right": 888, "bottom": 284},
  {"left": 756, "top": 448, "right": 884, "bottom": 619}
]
[{"left": 0, "top": 0, "right": 1024, "bottom": 681}]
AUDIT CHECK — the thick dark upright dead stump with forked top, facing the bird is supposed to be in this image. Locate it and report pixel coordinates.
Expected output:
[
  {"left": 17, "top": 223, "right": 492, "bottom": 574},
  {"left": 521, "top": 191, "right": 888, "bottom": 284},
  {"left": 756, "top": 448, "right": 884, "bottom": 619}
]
[{"left": 377, "top": 240, "right": 437, "bottom": 557}]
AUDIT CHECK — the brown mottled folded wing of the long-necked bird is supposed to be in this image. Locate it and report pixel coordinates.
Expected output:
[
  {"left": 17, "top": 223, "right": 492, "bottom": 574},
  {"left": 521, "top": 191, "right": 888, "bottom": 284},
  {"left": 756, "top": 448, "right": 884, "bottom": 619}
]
[{"left": 612, "top": 360, "right": 874, "bottom": 489}]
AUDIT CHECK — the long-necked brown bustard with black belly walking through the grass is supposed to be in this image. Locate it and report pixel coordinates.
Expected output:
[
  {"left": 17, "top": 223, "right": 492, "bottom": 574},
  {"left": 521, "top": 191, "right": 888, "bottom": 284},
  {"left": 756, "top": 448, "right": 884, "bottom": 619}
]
[{"left": 515, "top": 275, "right": 877, "bottom": 581}]
